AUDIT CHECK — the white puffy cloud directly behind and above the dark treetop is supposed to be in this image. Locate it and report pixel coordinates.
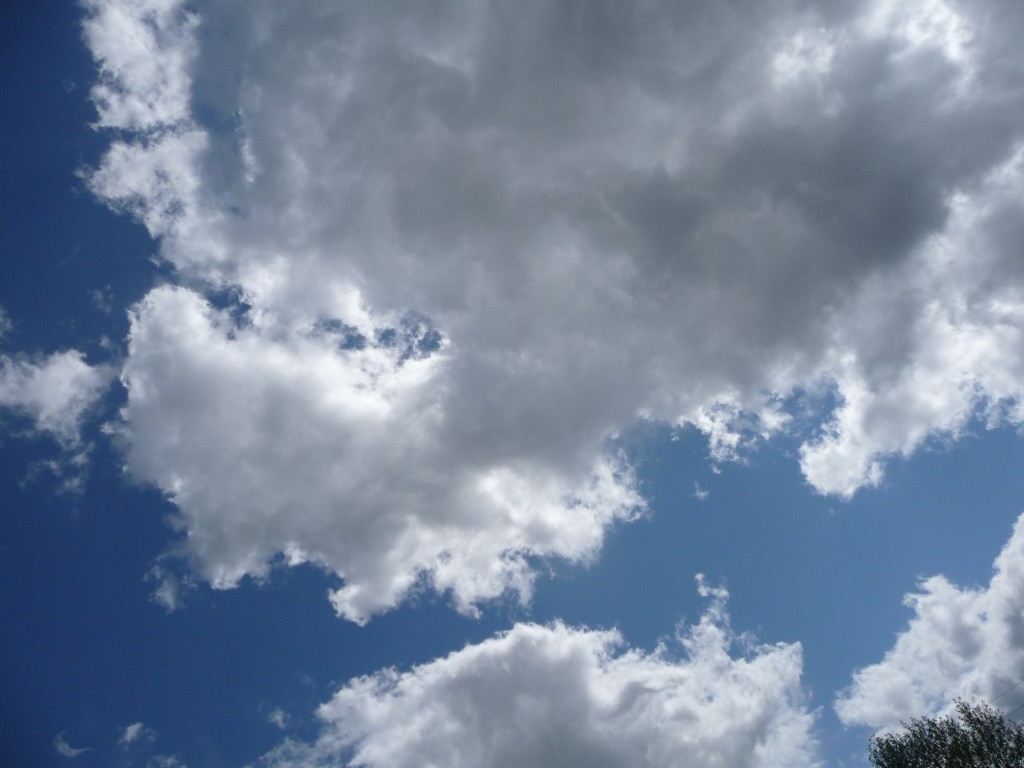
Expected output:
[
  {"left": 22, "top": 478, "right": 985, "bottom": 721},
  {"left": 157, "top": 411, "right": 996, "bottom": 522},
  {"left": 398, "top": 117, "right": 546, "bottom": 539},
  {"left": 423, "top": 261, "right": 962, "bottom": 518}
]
[{"left": 836, "top": 516, "right": 1024, "bottom": 728}]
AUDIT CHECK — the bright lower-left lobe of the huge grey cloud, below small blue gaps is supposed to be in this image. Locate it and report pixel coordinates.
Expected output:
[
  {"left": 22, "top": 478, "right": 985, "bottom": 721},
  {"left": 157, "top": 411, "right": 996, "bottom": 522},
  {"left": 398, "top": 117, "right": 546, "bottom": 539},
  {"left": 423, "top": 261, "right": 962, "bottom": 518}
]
[{"left": 122, "top": 288, "right": 640, "bottom": 621}]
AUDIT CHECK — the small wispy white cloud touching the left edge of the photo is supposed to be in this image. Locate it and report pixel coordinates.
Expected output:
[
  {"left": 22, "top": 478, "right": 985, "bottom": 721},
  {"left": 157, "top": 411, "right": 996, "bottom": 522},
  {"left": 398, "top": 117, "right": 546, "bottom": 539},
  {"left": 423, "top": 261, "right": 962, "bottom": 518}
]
[{"left": 0, "top": 349, "right": 114, "bottom": 449}]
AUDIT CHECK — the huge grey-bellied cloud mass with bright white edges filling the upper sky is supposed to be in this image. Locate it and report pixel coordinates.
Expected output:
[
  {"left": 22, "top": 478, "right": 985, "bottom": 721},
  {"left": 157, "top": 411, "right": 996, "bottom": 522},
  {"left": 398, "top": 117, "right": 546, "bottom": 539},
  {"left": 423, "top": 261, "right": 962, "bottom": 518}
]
[{"left": 86, "top": 0, "right": 1024, "bottom": 621}]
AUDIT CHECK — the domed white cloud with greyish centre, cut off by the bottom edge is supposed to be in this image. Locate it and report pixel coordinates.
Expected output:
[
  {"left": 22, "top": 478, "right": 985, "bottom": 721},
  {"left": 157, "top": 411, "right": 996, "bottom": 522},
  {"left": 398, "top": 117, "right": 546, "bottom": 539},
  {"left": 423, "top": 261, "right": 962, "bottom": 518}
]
[{"left": 261, "top": 584, "right": 818, "bottom": 768}]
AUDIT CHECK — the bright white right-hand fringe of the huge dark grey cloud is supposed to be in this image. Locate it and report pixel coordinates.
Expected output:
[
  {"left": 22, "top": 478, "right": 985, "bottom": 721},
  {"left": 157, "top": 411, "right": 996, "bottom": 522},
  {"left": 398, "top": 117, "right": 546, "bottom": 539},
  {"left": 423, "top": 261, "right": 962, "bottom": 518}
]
[{"left": 801, "top": 151, "right": 1024, "bottom": 497}]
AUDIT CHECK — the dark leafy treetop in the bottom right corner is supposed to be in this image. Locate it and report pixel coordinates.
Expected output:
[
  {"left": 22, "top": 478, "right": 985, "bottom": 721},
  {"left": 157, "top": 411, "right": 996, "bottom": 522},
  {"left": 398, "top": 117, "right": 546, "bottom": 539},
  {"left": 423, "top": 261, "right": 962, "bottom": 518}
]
[{"left": 867, "top": 698, "right": 1024, "bottom": 768}]
